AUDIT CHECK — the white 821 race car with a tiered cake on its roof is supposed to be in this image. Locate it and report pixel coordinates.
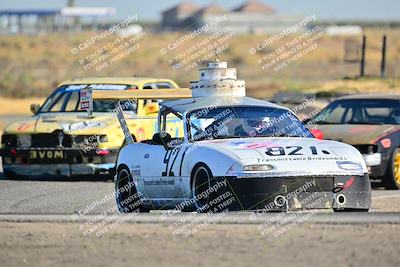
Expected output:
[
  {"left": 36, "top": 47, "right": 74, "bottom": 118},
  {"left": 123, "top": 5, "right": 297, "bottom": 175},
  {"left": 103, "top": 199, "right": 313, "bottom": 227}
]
[{"left": 93, "top": 61, "right": 371, "bottom": 212}]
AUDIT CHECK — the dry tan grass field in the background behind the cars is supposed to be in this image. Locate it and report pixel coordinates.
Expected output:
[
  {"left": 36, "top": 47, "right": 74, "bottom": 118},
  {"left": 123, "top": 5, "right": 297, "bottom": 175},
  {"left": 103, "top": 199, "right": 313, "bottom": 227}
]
[{"left": 0, "top": 29, "right": 400, "bottom": 98}]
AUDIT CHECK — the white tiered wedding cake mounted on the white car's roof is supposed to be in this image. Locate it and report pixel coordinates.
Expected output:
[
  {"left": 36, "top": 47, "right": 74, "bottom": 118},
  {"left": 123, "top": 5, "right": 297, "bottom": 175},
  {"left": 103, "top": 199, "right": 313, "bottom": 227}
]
[{"left": 190, "top": 58, "right": 246, "bottom": 97}]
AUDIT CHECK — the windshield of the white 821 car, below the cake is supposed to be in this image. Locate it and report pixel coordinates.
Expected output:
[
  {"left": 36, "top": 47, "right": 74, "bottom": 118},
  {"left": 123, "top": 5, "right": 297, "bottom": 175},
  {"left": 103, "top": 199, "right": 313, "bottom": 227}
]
[{"left": 188, "top": 107, "right": 313, "bottom": 141}]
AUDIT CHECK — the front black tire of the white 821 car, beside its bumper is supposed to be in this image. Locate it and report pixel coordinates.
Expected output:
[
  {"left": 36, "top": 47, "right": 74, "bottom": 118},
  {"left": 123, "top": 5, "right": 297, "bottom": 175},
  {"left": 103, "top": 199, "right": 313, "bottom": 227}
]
[{"left": 191, "top": 164, "right": 213, "bottom": 212}]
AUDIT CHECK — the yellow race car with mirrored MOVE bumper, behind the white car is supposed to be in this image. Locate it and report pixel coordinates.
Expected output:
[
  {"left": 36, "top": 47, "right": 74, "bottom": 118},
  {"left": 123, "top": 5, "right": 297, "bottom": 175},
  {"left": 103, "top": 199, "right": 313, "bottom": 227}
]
[{"left": 0, "top": 77, "right": 182, "bottom": 179}]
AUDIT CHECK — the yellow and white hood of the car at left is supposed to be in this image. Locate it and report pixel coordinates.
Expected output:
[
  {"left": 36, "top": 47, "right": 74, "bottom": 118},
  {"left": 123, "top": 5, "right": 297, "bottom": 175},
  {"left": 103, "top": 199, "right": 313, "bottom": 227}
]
[{"left": 4, "top": 113, "right": 118, "bottom": 134}]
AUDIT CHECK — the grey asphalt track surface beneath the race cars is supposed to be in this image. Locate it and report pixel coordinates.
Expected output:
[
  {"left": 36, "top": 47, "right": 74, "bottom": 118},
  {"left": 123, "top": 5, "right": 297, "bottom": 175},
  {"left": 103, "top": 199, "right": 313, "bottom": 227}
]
[{"left": 0, "top": 170, "right": 400, "bottom": 224}]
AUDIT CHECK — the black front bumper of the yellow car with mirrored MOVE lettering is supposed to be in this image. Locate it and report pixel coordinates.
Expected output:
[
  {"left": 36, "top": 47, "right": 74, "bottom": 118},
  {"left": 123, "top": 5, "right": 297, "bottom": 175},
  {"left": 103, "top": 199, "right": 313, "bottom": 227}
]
[{"left": 0, "top": 148, "right": 118, "bottom": 178}]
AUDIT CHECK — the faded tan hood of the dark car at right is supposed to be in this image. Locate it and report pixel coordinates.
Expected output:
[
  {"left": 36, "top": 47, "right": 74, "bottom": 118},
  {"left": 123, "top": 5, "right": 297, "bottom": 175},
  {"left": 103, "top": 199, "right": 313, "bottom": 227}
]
[{"left": 317, "top": 124, "right": 400, "bottom": 145}]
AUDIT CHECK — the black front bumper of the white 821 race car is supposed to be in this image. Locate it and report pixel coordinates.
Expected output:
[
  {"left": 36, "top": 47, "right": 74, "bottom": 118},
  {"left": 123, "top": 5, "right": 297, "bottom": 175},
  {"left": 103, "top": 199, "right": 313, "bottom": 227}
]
[{"left": 214, "top": 174, "right": 371, "bottom": 211}]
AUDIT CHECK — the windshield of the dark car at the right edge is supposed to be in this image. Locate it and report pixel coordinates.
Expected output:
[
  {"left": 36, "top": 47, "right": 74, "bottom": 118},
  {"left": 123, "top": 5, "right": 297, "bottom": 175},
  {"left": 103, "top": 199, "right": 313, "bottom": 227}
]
[{"left": 312, "top": 99, "right": 400, "bottom": 125}]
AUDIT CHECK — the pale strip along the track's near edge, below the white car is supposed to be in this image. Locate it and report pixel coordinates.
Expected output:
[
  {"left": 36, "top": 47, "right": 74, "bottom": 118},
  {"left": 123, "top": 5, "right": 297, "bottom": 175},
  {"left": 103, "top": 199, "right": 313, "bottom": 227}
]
[{"left": 0, "top": 211, "right": 400, "bottom": 225}]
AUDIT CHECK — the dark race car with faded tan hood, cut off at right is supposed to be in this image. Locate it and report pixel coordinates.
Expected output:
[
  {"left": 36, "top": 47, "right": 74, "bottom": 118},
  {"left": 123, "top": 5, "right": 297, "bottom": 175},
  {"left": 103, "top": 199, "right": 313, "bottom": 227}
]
[{"left": 306, "top": 94, "right": 400, "bottom": 189}]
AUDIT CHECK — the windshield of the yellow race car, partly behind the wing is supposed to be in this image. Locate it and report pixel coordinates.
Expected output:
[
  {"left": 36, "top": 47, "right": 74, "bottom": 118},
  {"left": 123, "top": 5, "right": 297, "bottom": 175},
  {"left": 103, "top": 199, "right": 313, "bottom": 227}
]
[{"left": 39, "top": 84, "right": 137, "bottom": 113}]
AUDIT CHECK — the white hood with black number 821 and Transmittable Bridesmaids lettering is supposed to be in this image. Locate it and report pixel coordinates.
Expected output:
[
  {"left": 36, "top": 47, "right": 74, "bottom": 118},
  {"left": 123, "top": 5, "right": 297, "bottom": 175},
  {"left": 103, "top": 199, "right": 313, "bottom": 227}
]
[{"left": 195, "top": 137, "right": 368, "bottom": 176}]
